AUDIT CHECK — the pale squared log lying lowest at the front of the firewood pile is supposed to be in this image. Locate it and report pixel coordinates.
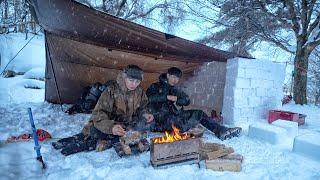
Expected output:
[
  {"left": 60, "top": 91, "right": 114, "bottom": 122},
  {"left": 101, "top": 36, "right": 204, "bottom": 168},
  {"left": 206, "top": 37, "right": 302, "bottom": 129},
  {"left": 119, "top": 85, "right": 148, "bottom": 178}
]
[{"left": 205, "top": 159, "right": 241, "bottom": 172}]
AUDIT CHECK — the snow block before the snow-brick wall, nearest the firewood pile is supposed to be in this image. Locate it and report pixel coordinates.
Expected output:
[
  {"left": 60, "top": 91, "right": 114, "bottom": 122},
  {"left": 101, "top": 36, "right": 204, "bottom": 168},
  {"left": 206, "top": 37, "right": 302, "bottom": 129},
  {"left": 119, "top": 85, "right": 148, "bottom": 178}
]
[{"left": 248, "top": 122, "right": 287, "bottom": 144}]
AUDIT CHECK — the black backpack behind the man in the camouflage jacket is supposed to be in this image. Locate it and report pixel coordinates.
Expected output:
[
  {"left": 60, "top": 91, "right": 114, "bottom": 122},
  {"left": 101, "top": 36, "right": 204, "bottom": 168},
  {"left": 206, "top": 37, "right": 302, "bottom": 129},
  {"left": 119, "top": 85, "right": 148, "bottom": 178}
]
[{"left": 65, "top": 80, "right": 116, "bottom": 115}]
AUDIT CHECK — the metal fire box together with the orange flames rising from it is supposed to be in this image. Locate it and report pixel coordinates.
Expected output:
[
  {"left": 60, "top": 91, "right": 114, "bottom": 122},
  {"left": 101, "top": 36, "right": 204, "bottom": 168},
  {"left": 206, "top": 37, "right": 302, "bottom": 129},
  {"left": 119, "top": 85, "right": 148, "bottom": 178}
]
[{"left": 150, "top": 125, "right": 200, "bottom": 167}]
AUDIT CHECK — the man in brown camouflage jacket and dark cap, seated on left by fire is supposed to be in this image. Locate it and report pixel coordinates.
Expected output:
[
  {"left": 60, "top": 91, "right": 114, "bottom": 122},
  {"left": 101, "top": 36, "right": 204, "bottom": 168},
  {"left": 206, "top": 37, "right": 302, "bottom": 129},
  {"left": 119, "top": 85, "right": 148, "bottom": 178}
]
[{"left": 52, "top": 65, "right": 153, "bottom": 155}]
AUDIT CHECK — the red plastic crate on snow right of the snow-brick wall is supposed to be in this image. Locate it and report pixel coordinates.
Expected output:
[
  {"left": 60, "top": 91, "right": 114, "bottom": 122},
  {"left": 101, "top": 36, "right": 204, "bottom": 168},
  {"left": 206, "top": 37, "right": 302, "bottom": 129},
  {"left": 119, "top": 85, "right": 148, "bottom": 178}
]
[{"left": 268, "top": 110, "right": 306, "bottom": 126}]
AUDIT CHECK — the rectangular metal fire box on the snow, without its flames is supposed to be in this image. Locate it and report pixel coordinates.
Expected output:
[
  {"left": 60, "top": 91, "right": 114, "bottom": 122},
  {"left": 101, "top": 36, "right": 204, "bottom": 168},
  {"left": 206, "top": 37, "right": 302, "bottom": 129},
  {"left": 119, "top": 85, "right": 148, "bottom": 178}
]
[{"left": 150, "top": 138, "right": 200, "bottom": 167}]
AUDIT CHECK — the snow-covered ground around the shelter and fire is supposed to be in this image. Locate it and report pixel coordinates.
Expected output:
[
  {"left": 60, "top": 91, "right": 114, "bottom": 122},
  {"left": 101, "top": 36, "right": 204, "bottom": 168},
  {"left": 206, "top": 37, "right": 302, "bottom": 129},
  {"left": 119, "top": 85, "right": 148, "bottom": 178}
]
[{"left": 0, "top": 33, "right": 320, "bottom": 180}]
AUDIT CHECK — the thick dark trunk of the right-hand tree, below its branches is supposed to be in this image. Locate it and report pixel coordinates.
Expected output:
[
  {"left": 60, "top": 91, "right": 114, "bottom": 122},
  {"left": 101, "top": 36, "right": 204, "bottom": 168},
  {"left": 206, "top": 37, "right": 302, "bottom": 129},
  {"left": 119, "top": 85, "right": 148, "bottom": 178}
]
[{"left": 293, "top": 48, "right": 309, "bottom": 105}]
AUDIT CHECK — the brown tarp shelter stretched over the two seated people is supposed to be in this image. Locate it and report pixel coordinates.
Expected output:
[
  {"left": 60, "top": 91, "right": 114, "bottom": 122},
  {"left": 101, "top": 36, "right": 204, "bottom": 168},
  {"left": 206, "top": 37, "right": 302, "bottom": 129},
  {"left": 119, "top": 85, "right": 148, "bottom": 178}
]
[{"left": 28, "top": 0, "right": 239, "bottom": 103}]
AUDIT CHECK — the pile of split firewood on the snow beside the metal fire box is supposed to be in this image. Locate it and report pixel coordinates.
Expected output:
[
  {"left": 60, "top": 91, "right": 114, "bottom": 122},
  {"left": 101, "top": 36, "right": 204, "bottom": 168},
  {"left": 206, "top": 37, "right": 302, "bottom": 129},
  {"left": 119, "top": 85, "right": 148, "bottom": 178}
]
[{"left": 199, "top": 142, "right": 243, "bottom": 172}]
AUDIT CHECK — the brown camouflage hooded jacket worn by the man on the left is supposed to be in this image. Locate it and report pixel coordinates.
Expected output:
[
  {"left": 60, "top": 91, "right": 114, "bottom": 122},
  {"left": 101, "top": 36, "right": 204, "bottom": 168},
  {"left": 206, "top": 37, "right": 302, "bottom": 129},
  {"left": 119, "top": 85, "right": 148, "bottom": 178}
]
[{"left": 82, "top": 73, "right": 148, "bottom": 136}]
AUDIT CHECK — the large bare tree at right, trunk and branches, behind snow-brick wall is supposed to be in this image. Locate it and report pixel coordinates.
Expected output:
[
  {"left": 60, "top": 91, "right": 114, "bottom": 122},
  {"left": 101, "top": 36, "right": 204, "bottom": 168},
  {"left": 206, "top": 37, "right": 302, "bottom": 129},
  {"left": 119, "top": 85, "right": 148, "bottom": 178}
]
[{"left": 182, "top": 0, "right": 320, "bottom": 104}]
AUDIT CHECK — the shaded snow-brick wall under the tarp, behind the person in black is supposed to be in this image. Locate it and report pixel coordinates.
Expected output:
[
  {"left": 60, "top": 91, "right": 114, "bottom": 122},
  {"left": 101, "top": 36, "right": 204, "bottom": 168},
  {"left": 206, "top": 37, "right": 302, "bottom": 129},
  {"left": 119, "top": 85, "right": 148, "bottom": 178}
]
[{"left": 182, "top": 61, "right": 226, "bottom": 114}]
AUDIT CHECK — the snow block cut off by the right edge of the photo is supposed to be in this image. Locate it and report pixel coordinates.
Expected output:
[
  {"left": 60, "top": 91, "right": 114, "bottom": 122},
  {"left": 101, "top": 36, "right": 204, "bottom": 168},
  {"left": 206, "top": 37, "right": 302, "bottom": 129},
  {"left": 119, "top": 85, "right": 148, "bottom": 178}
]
[{"left": 293, "top": 133, "right": 320, "bottom": 161}]
